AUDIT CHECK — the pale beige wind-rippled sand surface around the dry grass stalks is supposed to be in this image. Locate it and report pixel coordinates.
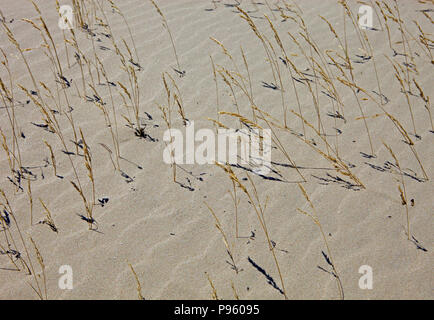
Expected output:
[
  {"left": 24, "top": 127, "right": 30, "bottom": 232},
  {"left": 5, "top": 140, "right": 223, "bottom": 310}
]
[{"left": 0, "top": 0, "right": 434, "bottom": 299}]
